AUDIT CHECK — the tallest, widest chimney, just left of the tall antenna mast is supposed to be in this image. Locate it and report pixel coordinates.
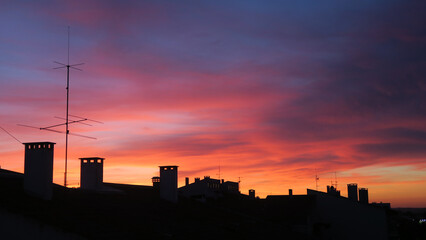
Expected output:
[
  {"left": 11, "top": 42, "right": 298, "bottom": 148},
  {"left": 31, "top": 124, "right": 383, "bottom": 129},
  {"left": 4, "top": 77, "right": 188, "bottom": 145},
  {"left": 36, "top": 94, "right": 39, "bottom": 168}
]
[{"left": 24, "top": 142, "right": 55, "bottom": 200}]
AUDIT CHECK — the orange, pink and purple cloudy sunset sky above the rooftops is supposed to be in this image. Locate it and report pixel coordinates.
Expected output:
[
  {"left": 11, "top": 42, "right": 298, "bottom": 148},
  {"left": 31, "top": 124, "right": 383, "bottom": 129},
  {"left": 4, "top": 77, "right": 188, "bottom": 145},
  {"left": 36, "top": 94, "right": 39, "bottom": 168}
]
[{"left": 0, "top": 0, "right": 426, "bottom": 207}]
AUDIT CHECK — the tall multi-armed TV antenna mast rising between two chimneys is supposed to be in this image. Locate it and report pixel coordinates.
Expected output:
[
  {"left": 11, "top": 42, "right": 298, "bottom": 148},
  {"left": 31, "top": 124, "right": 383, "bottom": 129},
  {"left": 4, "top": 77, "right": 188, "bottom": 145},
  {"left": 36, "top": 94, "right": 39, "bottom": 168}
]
[{"left": 18, "top": 26, "right": 103, "bottom": 187}]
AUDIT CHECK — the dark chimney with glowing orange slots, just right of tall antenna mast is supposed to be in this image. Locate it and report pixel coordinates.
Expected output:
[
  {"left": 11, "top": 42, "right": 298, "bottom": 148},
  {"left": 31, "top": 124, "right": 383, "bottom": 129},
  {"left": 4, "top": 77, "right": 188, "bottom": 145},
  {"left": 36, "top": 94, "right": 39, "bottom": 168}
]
[{"left": 80, "top": 157, "right": 105, "bottom": 190}]
